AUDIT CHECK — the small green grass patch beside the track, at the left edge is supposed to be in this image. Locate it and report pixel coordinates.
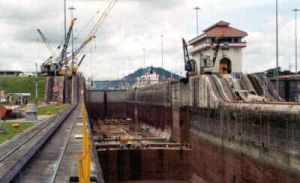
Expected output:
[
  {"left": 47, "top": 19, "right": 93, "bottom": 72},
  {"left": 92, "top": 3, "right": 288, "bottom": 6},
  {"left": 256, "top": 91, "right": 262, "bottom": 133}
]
[{"left": 0, "top": 122, "right": 34, "bottom": 144}]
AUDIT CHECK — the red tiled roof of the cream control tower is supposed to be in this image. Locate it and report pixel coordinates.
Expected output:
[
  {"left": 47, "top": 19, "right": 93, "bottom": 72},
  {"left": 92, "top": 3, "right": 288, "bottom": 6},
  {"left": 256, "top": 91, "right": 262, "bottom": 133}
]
[{"left": 203, "top": 20, "right": 248, "bottom": 37}]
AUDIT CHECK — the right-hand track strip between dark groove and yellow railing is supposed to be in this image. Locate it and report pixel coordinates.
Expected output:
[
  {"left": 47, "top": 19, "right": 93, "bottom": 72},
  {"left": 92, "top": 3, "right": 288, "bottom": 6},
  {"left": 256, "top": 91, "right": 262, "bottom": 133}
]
[{"left": 11, "top": 106, "right": 80, "bottom": 183}]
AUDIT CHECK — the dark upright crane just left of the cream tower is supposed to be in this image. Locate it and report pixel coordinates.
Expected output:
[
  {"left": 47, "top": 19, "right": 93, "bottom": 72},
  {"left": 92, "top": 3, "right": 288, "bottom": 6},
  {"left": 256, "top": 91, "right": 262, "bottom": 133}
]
[{"left": 182, "top": 38, "right": 197, "bottom": 78}]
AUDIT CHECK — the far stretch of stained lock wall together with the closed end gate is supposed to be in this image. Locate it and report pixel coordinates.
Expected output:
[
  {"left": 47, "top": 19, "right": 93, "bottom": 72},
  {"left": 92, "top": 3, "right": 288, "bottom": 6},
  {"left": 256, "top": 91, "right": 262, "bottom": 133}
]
[{"left": 86, "top": 82, "right": 189, "bottom": 142}]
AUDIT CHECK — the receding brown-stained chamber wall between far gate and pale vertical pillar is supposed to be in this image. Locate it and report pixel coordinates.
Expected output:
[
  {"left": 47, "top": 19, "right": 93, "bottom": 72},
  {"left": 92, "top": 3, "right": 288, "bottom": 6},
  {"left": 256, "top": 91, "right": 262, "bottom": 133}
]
[{"left": 127, "top": 83, "right": 172, "bottom": 138}]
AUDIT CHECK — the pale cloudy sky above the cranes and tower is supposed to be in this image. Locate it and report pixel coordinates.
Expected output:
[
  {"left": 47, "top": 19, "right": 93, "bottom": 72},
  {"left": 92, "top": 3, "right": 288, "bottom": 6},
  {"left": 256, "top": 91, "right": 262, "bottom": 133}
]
[{"left": 0, "top": 0, "right": 300, "bottom": 79}]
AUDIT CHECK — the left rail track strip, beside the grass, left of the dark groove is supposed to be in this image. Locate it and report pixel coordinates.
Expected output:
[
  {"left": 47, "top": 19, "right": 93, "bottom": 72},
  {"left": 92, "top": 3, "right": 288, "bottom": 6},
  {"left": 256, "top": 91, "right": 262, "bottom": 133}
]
[{"left": 0, "top": 105, "right": 75, "bottom": 182}]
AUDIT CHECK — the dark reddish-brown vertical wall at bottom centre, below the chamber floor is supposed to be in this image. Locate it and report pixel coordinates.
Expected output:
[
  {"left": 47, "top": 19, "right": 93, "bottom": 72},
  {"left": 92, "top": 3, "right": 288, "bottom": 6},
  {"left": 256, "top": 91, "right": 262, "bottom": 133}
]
[{"left": 98, "top": 149, "right": 191, "bottom": 182}]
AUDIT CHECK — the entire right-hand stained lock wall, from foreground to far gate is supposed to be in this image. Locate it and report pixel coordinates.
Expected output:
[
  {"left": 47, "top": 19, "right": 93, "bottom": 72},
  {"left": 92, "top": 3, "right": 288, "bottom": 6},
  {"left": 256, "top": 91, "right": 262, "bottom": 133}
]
[{"left": 87, "top": 75, "right": 300, "bottom": 182}]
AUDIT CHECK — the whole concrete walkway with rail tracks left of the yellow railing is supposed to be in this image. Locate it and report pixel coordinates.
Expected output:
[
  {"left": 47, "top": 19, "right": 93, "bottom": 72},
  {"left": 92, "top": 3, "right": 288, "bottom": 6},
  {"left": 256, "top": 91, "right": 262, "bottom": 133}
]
[{"left": 0, "top": 75, "right": 102, "bottom": 183}]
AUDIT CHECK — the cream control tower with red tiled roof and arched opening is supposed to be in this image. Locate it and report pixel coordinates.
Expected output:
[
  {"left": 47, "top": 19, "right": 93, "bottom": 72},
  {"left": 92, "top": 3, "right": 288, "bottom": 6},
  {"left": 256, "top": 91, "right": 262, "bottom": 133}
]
[{"left": 189, "top": 21, "right": 248, "bottom": 74}]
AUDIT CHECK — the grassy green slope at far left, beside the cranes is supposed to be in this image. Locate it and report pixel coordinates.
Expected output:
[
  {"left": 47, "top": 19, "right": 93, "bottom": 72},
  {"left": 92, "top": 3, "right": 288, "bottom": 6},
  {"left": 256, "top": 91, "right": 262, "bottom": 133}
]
[{"left": 0, "top": 77, "right": 46, "bottom": 102}]
